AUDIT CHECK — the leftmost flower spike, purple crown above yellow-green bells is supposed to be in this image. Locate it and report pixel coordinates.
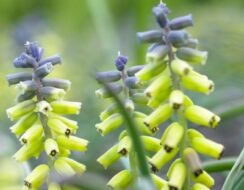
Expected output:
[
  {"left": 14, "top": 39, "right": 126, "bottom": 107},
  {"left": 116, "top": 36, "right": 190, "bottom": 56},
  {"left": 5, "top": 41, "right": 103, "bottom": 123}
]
[{"left": 7, "top": 42, "right": 88, "bottom": 189}]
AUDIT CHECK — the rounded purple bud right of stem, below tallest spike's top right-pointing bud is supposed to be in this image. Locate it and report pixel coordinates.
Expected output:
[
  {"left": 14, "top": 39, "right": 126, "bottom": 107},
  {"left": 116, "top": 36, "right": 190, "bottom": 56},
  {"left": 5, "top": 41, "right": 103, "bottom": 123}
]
[{"left": 168, "top": 30, "right": 188, "bottom": 47}]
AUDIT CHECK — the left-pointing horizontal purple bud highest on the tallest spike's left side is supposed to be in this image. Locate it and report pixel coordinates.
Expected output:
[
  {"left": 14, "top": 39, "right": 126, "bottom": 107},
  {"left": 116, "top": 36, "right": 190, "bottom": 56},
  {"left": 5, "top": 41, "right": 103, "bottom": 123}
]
[{"left": 137, "top": 30, "right": 163, "bottom": 43}]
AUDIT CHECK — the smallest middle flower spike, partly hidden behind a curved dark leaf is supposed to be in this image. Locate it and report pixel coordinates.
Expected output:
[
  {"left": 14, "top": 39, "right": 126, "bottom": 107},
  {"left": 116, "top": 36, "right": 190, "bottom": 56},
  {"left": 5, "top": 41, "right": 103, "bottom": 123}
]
[{"left": 96, "top": 52, "right": 164, "bottom": 189}]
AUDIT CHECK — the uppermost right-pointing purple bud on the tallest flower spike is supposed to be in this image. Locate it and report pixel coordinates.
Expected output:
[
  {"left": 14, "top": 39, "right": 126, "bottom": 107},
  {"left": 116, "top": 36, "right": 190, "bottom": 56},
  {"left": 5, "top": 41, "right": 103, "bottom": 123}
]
[{"left": 169, "top": 14, "right": 193, "bottom": 30}]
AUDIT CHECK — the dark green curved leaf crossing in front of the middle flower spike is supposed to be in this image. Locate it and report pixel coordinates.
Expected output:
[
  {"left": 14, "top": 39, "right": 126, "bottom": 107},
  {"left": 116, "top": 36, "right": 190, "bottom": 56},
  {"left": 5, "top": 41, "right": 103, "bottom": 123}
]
[{"left": 104, "top": 84, "right": 151, "bottom": 179}]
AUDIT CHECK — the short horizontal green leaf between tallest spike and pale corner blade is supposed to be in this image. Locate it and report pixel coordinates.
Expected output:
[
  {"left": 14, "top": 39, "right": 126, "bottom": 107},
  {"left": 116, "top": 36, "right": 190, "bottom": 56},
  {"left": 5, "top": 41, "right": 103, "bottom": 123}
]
[{"left": 202, "top": 158, "right": 244, "bottom": 173}]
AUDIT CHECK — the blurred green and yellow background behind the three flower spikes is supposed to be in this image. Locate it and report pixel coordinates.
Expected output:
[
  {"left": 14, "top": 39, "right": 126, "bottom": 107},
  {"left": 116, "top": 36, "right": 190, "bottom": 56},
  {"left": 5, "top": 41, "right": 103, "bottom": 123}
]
[{"left": 0, "top": 0, "right": 244, "bottom": 190}]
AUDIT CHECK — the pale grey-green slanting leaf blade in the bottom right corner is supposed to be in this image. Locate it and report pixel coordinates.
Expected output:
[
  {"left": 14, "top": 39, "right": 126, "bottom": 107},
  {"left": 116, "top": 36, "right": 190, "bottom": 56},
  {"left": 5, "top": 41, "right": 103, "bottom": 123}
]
[{"left": 222, "top": 148, "right": 244, "bottom": 190}]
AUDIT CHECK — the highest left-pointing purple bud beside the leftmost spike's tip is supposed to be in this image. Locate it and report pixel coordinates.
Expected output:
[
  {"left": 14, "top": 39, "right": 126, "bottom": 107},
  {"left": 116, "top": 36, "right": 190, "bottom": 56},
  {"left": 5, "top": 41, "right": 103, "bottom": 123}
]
[{"left": 13, "top": 53, "right": 37, "bottom": 68}]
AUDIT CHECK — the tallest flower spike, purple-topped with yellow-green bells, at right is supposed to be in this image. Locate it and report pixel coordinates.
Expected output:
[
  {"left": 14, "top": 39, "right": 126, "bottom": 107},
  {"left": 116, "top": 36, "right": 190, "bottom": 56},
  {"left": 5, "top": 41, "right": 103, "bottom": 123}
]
[{"left": 135, "top": 3, "right": 224, "bottom": 190}]
